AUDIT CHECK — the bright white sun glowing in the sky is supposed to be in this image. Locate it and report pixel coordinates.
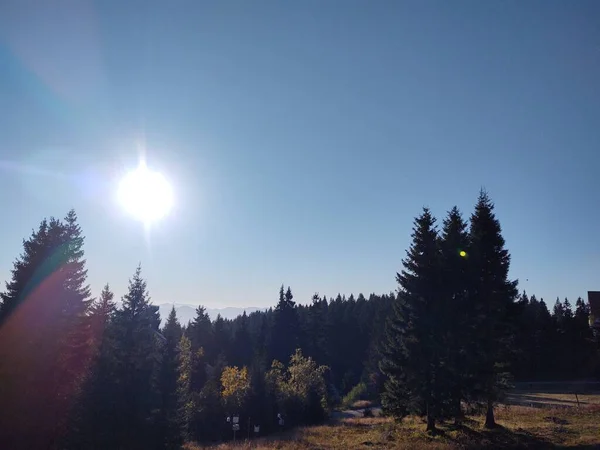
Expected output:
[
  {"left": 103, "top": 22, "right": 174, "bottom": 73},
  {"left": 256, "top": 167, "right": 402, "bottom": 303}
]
[{"left": 117, "top": 162, "right": 173, "bottom": 225}]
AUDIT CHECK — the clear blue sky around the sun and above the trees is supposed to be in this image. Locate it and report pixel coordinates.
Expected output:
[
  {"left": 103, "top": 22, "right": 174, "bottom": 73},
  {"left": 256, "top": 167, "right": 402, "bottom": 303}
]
[{"left": 0, "top": 0, "right": 600, "bottom": 307}]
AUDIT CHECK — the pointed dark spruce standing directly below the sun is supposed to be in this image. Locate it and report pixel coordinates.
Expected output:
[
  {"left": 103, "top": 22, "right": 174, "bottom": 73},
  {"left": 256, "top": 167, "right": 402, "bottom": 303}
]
[{"left": 115, "top": 266, "right": 160, "bottom": 448}]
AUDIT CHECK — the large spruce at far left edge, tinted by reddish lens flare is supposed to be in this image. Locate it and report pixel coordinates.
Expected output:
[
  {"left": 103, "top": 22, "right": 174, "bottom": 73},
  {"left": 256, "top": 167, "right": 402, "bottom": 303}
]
[{"left": 0, "top": 211, "right": 91, "bottom": 448}]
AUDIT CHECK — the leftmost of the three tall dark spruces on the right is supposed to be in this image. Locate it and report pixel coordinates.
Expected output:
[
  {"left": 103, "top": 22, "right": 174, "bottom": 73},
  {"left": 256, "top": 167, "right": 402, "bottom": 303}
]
[{"left": 381, "top": 208, "right": 444, "bottom": 431}]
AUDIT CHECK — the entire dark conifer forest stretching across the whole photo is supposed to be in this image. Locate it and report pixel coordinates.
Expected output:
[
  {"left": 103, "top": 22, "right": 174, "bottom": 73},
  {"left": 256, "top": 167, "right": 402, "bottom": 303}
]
[{"left": 0, "top": 191, "right": 600, "bottom": 449}]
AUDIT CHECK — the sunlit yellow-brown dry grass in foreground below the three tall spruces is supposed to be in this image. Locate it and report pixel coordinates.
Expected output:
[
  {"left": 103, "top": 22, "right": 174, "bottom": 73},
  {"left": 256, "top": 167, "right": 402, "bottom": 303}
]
[{"left": 186, "top": 406, "right": 600, "bottom": 450}]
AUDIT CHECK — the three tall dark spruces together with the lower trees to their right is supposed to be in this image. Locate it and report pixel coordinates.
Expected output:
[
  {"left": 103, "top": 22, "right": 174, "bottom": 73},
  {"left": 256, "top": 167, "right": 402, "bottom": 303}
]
[{"left": 380, "top": 192, "right": 598, "bottom": 431}]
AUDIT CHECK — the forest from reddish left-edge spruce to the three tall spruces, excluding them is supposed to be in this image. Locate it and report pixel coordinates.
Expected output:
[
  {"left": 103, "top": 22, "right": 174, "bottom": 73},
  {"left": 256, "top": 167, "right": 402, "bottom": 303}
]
[{"left": 0, "top": 211, "right": 393, "bottom": 449}]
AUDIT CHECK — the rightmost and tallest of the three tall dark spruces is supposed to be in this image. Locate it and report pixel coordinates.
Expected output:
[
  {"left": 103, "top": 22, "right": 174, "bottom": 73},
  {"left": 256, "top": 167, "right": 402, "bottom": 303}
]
[{"left": 469, "top": 191, "right": 517, "bottom": 428}]
